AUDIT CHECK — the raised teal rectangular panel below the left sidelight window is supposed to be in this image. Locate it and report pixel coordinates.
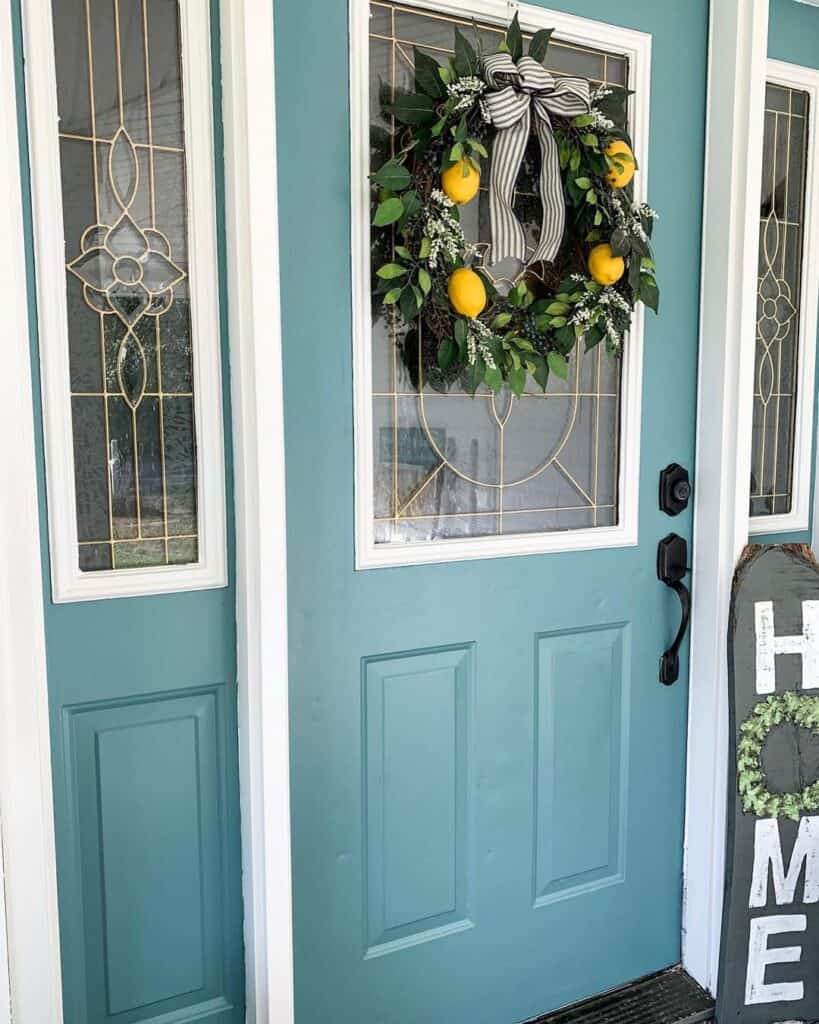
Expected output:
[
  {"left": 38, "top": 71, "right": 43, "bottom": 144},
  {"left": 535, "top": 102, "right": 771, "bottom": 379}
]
[{"left": 66, "top": 686, "right": 231, "bottom": 1022}]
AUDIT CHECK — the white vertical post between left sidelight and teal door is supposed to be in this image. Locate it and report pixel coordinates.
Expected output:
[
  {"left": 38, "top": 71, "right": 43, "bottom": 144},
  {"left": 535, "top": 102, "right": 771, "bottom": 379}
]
[{"left": 221, "top": 0, "right": 295, "bottom": 1024}]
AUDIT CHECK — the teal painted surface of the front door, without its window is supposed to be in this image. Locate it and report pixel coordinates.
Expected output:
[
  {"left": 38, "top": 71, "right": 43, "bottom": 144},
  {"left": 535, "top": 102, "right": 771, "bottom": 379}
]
[{"left": 275, "top": 0, "right": 707, "bottom": 1024}]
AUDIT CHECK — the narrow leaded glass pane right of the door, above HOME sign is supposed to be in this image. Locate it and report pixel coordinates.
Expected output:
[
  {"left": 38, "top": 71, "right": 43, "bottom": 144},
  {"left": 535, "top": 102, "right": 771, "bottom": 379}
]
[{"left": 750, "top": 83, "right": 809, "bottom": 516}]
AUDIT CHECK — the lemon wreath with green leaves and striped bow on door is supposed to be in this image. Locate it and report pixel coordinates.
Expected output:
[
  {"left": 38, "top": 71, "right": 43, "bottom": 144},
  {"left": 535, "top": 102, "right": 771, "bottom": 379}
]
[{"left": 371, "top": 14, "right": 659, "bottom": 395}]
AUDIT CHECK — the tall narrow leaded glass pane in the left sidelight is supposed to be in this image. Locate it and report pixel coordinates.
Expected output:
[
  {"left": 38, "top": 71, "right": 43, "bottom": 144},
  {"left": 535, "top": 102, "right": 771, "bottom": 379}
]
[{"left": 52, "top": 0, "right": 199, "bottom": 571}]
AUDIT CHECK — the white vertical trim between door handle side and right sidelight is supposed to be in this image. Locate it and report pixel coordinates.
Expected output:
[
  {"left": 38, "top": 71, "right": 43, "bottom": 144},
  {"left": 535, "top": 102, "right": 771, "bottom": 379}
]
[{"left": 683, "top": 0, "right": 768, "bottom": 992}]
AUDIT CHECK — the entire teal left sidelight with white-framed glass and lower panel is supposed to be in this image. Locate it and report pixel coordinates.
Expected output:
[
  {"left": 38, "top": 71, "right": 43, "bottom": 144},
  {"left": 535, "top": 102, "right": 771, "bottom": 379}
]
[{"left": 12, "top": 0, "right": 245, "bottom": 1024}]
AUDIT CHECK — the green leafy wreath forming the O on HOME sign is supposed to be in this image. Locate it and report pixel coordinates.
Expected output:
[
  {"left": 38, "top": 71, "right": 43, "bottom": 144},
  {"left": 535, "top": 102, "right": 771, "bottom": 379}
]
[{"left": 736, "top": 690, "right": 819, "bottom": 821}]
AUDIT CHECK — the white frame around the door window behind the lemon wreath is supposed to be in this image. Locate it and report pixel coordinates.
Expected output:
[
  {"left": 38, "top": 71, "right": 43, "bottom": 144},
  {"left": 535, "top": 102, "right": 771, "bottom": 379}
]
[{"left": 350, "top": 0, "right": 651, "bottom": 569}]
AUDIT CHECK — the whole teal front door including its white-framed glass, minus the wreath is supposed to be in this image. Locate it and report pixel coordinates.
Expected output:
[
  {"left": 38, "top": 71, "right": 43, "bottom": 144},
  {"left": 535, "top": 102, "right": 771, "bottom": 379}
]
[{"left": 275, "top": 0, "right": 707, "bottom": 1024}]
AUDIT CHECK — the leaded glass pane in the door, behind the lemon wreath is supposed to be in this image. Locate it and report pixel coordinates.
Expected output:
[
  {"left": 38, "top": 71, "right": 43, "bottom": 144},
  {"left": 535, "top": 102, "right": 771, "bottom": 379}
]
[{"left": 370, "top": 2, "right": 629, "bottom": 544}]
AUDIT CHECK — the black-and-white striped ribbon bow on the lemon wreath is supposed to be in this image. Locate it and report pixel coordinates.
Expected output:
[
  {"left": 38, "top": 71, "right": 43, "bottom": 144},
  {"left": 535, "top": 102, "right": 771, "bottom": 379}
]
[{"left": 483, "top": 53, "right": 591, "bottom": 263}]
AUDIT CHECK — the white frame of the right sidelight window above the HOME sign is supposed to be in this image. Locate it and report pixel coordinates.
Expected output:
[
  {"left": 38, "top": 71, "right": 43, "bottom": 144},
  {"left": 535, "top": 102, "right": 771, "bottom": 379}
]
[{"left": 749, "top": 59, "right": 819, "bottom": 535}]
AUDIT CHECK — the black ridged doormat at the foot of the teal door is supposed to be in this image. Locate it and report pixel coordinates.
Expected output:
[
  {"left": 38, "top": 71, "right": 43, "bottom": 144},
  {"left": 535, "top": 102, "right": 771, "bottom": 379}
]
[{"left": 530, "top": 967, "right": 714, "bottom": 1024}]
